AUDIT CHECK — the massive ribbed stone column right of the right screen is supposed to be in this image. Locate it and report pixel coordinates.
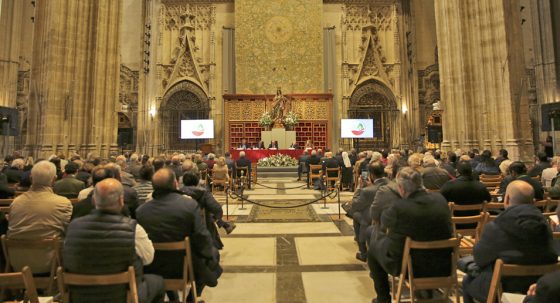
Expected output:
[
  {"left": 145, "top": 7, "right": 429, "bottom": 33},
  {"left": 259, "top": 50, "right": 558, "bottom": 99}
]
[{"left": 435, "top": 0, "right": 531, "bottom": 159}]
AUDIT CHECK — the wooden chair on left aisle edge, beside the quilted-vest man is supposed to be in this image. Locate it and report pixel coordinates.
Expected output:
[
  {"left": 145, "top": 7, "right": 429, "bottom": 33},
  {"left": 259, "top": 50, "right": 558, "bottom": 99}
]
[{"left": 153, "top": 237, "right": 198, "bottom": 303}]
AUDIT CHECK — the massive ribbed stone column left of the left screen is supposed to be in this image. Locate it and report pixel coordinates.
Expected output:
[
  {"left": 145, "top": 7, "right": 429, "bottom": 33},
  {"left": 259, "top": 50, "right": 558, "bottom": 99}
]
[{"left": 26, "top": 0, "right": 121, "bottom": 157}]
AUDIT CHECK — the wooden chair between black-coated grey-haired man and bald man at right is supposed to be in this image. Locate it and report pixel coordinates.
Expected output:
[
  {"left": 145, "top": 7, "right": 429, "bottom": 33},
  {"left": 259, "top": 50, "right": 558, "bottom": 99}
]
[{"left": 451, "top": 212, "right": 487, "bottom": 256}]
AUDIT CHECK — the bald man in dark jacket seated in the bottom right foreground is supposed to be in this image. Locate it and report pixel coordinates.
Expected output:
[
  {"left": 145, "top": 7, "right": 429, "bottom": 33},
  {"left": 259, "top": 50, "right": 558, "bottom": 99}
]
[{"left": 463, "top": 180, "right": 558, "bottom": 303}]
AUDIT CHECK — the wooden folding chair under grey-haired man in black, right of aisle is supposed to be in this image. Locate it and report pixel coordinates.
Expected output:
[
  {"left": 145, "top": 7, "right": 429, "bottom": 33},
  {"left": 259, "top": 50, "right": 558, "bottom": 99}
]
[{"left": 393, "top": 237, "right": 460, "bottom": 303}]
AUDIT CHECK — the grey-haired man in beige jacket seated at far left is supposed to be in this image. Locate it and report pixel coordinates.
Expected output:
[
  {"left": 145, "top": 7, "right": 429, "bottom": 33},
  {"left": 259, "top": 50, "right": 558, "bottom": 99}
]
[{"left": 8, "top": 161, "right": 72, "bottom": 273}]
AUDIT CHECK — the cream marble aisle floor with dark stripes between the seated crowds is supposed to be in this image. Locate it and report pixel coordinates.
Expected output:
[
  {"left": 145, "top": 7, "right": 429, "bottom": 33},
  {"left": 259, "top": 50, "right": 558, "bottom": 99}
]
[{"left": 202, "top": 178, "right": 375, "bottom": 303}]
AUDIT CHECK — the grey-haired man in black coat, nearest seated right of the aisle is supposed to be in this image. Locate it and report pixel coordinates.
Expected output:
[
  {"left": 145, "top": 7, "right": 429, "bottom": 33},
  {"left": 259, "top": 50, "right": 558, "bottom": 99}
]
[{"left": 368, "top": 167, "right": 453, "bottom": 303}]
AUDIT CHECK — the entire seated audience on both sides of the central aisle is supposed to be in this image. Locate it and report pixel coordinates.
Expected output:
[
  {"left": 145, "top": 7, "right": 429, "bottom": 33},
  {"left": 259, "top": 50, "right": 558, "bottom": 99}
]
[{"left": 0, "top": 149, "right": 560, "bottom": 302}]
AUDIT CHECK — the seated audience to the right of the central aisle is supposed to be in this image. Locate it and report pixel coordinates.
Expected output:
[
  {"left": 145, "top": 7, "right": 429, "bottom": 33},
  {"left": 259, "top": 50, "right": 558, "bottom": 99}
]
[{"left": 344, "top": 149, "right": 560, "bottom": 302}]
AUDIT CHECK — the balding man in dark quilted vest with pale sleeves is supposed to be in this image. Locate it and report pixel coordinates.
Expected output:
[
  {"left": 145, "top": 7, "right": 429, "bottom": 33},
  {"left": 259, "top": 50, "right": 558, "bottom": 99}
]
[{"left": 62, "top": 178, "right": 165, "bottom": 303}]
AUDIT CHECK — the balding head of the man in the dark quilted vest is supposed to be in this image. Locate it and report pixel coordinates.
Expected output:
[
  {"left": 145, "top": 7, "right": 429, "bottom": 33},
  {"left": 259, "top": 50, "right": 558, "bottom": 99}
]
[{"left": 93, "top": 178, "right": 124, "bottom": 212}]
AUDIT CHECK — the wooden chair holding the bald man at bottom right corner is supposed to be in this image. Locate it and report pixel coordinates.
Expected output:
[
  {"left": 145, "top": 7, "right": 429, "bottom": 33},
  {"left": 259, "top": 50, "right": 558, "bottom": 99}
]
[{"left": 486, "top": 259, "right": 560, "bottom": 303}]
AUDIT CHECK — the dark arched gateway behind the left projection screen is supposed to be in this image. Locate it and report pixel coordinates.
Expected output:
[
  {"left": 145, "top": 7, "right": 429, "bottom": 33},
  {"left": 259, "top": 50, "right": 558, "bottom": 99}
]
[{"left": 159, "top": 80, "right": 210, "bottom": 150}]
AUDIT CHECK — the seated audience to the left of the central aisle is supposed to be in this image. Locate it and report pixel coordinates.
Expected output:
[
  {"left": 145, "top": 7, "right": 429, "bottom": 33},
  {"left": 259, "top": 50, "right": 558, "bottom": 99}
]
[{"left": 0, "top": 152, "right": 258, "bottom": 302}]
